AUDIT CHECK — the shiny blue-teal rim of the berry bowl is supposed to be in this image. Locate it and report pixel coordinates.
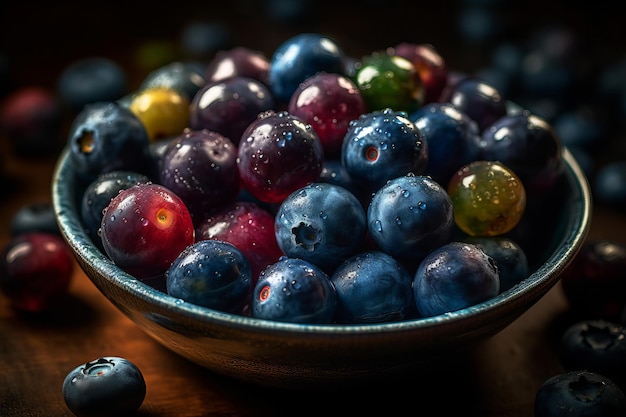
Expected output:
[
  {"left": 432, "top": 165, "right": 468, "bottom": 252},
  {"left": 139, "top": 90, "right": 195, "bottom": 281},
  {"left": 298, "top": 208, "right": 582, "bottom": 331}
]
[{"left": 51, "top": 146, "right": 592, "bottom": 337}]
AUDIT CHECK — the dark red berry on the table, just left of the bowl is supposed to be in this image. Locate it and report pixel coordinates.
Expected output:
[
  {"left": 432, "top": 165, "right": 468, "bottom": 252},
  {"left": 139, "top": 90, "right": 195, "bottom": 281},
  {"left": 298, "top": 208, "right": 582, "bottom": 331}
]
[{"left": 0, "top": 232, "right": 74, "bottom": 313}]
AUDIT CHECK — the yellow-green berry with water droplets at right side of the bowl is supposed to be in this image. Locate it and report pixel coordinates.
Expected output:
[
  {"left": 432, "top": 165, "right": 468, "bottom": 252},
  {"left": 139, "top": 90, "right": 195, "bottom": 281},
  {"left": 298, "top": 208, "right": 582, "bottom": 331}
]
[{"left": 448, "top": 160, "right": 526, "bottom": 236}]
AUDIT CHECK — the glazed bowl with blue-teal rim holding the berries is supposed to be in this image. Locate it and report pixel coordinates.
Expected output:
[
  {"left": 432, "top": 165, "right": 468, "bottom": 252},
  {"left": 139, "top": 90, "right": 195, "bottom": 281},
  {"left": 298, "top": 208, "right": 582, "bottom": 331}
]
[{"left": 52, "top": 148, "right": 591, "bottom": 388}]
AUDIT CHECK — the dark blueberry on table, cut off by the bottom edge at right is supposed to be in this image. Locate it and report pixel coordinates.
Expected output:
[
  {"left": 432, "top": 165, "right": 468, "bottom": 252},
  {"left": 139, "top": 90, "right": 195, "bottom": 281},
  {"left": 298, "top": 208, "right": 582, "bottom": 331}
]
[{"left": 534, "top": 370, "right": 626, "bottom": 417}]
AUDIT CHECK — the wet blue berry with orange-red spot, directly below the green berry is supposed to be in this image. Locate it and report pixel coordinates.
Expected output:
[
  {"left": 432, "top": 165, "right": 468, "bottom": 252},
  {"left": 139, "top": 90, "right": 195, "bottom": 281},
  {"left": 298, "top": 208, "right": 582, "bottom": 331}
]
[{"left": 341, "top": 109, "right": 428, "bottom": 192}]
